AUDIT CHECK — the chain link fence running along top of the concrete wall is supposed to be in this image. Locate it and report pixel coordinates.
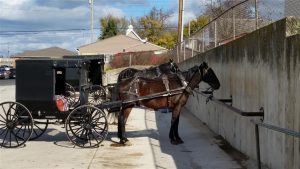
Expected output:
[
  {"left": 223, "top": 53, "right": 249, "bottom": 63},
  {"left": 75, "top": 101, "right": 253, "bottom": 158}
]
[{"left": 169, "top": 0, "right": 300, "bottom": 63}]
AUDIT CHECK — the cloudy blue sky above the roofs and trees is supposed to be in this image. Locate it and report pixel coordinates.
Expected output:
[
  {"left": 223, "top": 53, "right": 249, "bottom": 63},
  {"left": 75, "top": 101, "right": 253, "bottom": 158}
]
[{"left": 0, "top": 0, "right": 209, "bottom": 57}]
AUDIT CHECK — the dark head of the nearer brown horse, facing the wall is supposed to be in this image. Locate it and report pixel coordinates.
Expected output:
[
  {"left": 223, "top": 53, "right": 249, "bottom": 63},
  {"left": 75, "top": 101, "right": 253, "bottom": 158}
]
[{"left": 199, "top": 62, "right": 220, "bottom": 90}]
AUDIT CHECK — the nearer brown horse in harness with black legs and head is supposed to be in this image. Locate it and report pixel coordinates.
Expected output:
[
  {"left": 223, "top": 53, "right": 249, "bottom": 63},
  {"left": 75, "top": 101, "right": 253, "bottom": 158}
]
[{"left": 118, "top": 62, "right": 220, "bottom": 145}]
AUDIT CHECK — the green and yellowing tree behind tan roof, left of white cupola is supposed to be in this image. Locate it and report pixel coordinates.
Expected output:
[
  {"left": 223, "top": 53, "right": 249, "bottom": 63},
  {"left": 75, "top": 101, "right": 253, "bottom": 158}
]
[{"left": 99, "top": 15, "right": 128, "bottom": 39}]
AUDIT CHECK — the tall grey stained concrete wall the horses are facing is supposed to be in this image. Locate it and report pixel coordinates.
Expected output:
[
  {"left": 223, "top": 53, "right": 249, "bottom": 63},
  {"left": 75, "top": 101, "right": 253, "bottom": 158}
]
[{"left": 180, "top": 18, "right": 300, "bottom": 169}]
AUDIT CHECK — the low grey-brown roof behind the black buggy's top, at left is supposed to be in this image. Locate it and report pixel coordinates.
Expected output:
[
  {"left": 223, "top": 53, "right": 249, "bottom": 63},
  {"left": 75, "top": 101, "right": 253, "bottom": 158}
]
[{"left": 14, "top": 47, "right": 76, "bottom": 58}]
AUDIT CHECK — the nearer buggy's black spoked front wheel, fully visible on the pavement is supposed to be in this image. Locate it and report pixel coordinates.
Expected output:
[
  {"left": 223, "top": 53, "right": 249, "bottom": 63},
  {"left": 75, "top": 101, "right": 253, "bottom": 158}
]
[{"left": 65, "top": 105, "right": 108, "bottom": 148}]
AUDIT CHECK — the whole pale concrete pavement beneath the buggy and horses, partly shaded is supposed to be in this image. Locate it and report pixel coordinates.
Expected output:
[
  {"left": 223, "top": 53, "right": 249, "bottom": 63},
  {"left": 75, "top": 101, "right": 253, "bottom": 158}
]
[{"left": 0, "top": 80, "right": 248, "bottom": 169}]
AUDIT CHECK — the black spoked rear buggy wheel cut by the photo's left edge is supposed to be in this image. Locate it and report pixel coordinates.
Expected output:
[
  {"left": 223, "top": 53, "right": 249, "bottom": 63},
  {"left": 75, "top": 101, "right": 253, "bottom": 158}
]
[{"left": 0, "top": 102, "right": 33, "bottom": 148}]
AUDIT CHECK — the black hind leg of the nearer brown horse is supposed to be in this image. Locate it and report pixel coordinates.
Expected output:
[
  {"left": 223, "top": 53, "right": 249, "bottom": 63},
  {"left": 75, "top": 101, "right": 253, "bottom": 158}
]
[{"left": 118, "top": 108, "right": 132, "bottom": 144}]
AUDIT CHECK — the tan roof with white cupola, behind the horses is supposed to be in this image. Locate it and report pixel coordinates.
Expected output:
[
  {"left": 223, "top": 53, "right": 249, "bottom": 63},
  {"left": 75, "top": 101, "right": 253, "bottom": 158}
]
[{"left": 79, "top": 27, "right": 167, "bottom": 54}]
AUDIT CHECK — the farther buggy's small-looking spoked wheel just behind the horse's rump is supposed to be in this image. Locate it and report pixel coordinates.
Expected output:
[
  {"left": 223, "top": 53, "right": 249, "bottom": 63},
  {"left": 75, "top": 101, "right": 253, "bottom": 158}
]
[{"left": 88, "top": 85, "right": 106, "bottom": 105}]
